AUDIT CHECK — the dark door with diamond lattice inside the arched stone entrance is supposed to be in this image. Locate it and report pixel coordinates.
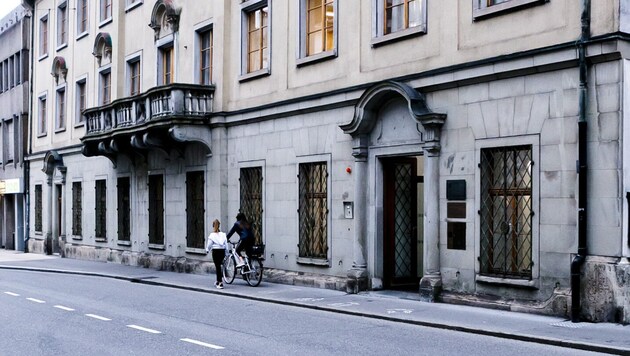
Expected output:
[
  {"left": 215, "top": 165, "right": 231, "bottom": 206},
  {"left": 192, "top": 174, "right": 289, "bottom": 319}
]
[{"left": 383, "top": 157, "right": 418, "bottom": 288}]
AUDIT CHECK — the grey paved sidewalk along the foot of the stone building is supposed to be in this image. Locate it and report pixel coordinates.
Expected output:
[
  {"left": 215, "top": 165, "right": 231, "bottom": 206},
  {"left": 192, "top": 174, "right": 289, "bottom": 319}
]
[{"left": 0, "top": 250, "right": 630, "bottom": 355}]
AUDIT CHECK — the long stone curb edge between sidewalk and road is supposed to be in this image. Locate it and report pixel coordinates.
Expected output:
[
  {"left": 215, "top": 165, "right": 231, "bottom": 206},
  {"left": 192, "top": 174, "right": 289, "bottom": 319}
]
[{"left": 0, "top": 265, "right": 630, "bottom": 355}]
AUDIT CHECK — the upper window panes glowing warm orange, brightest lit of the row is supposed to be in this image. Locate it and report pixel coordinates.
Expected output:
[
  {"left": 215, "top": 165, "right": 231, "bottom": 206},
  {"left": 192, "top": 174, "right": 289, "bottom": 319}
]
[{"left": 300, "top": 0, "right": 337, "bottom": 58}]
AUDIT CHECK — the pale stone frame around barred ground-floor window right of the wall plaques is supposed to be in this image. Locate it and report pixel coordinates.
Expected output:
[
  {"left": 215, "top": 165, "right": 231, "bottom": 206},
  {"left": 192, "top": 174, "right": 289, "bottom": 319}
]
[{"left": 474, "top": 135, "right": 541, "bottom": 288}]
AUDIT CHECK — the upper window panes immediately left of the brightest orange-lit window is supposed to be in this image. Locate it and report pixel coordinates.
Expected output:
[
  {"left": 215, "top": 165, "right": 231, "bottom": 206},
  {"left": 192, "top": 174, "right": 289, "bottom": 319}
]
[{"left": 242, "top": 1, "right": 270, "bottom": 78}]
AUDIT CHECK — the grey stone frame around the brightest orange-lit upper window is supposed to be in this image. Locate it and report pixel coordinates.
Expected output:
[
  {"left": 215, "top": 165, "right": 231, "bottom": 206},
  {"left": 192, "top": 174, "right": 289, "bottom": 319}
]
[{"left": 296, "top": 0, "right": 339, "bottom": 66}]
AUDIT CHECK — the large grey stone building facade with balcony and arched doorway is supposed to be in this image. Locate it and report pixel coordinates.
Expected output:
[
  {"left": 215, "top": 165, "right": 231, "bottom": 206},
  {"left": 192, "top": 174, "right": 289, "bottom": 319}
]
[{"left": 22, "top": 0, "right": 630, "bottom": 322}]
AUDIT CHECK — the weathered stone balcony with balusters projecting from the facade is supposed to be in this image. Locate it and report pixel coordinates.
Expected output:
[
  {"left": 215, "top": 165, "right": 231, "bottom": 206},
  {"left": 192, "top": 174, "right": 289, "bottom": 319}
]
[{"left": 81, "top": 84, "right": 214, "bottom": 165}]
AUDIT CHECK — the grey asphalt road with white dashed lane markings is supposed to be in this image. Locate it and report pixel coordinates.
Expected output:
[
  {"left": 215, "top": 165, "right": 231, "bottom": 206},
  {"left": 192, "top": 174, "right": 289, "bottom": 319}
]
[{"left": 0, "top": 270, "right": 608, "bottom": 356}]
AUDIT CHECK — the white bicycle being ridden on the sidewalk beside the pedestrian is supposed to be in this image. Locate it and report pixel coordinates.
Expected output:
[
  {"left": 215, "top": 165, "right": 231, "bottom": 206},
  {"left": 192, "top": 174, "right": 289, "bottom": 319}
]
[{"left": 221, "top": 241, "right": 265, "bottom": 287}]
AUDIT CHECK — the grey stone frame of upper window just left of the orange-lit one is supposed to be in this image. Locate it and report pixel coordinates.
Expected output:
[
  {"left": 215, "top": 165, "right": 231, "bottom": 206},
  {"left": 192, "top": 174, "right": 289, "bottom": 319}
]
[{"left": 238, "top": 0, "right": 273, "bottom": 82}]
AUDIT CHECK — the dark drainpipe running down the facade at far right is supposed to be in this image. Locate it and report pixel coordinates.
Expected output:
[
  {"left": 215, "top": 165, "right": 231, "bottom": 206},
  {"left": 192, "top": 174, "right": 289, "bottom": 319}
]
[{"left": 571, "top": 0, "right": 591, "bottom": 323}]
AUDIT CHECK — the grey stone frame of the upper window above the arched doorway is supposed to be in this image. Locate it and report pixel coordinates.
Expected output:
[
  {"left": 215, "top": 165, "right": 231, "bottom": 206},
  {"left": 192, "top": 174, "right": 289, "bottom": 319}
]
[{"left": 370, "top": 0, "right": 428, "bottom": 47}]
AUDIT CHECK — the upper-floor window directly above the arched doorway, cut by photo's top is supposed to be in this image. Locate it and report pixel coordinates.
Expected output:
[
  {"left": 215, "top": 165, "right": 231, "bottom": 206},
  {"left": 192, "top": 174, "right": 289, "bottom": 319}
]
[{"left": 372, "top": 0, "right": 427, "bottom": 45}]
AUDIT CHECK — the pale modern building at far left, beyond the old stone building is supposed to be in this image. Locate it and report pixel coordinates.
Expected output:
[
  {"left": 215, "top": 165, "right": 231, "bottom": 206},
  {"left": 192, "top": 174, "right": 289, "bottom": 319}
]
[{"left": 0, "top": 6, "right": 31, "bottom": 251}]
